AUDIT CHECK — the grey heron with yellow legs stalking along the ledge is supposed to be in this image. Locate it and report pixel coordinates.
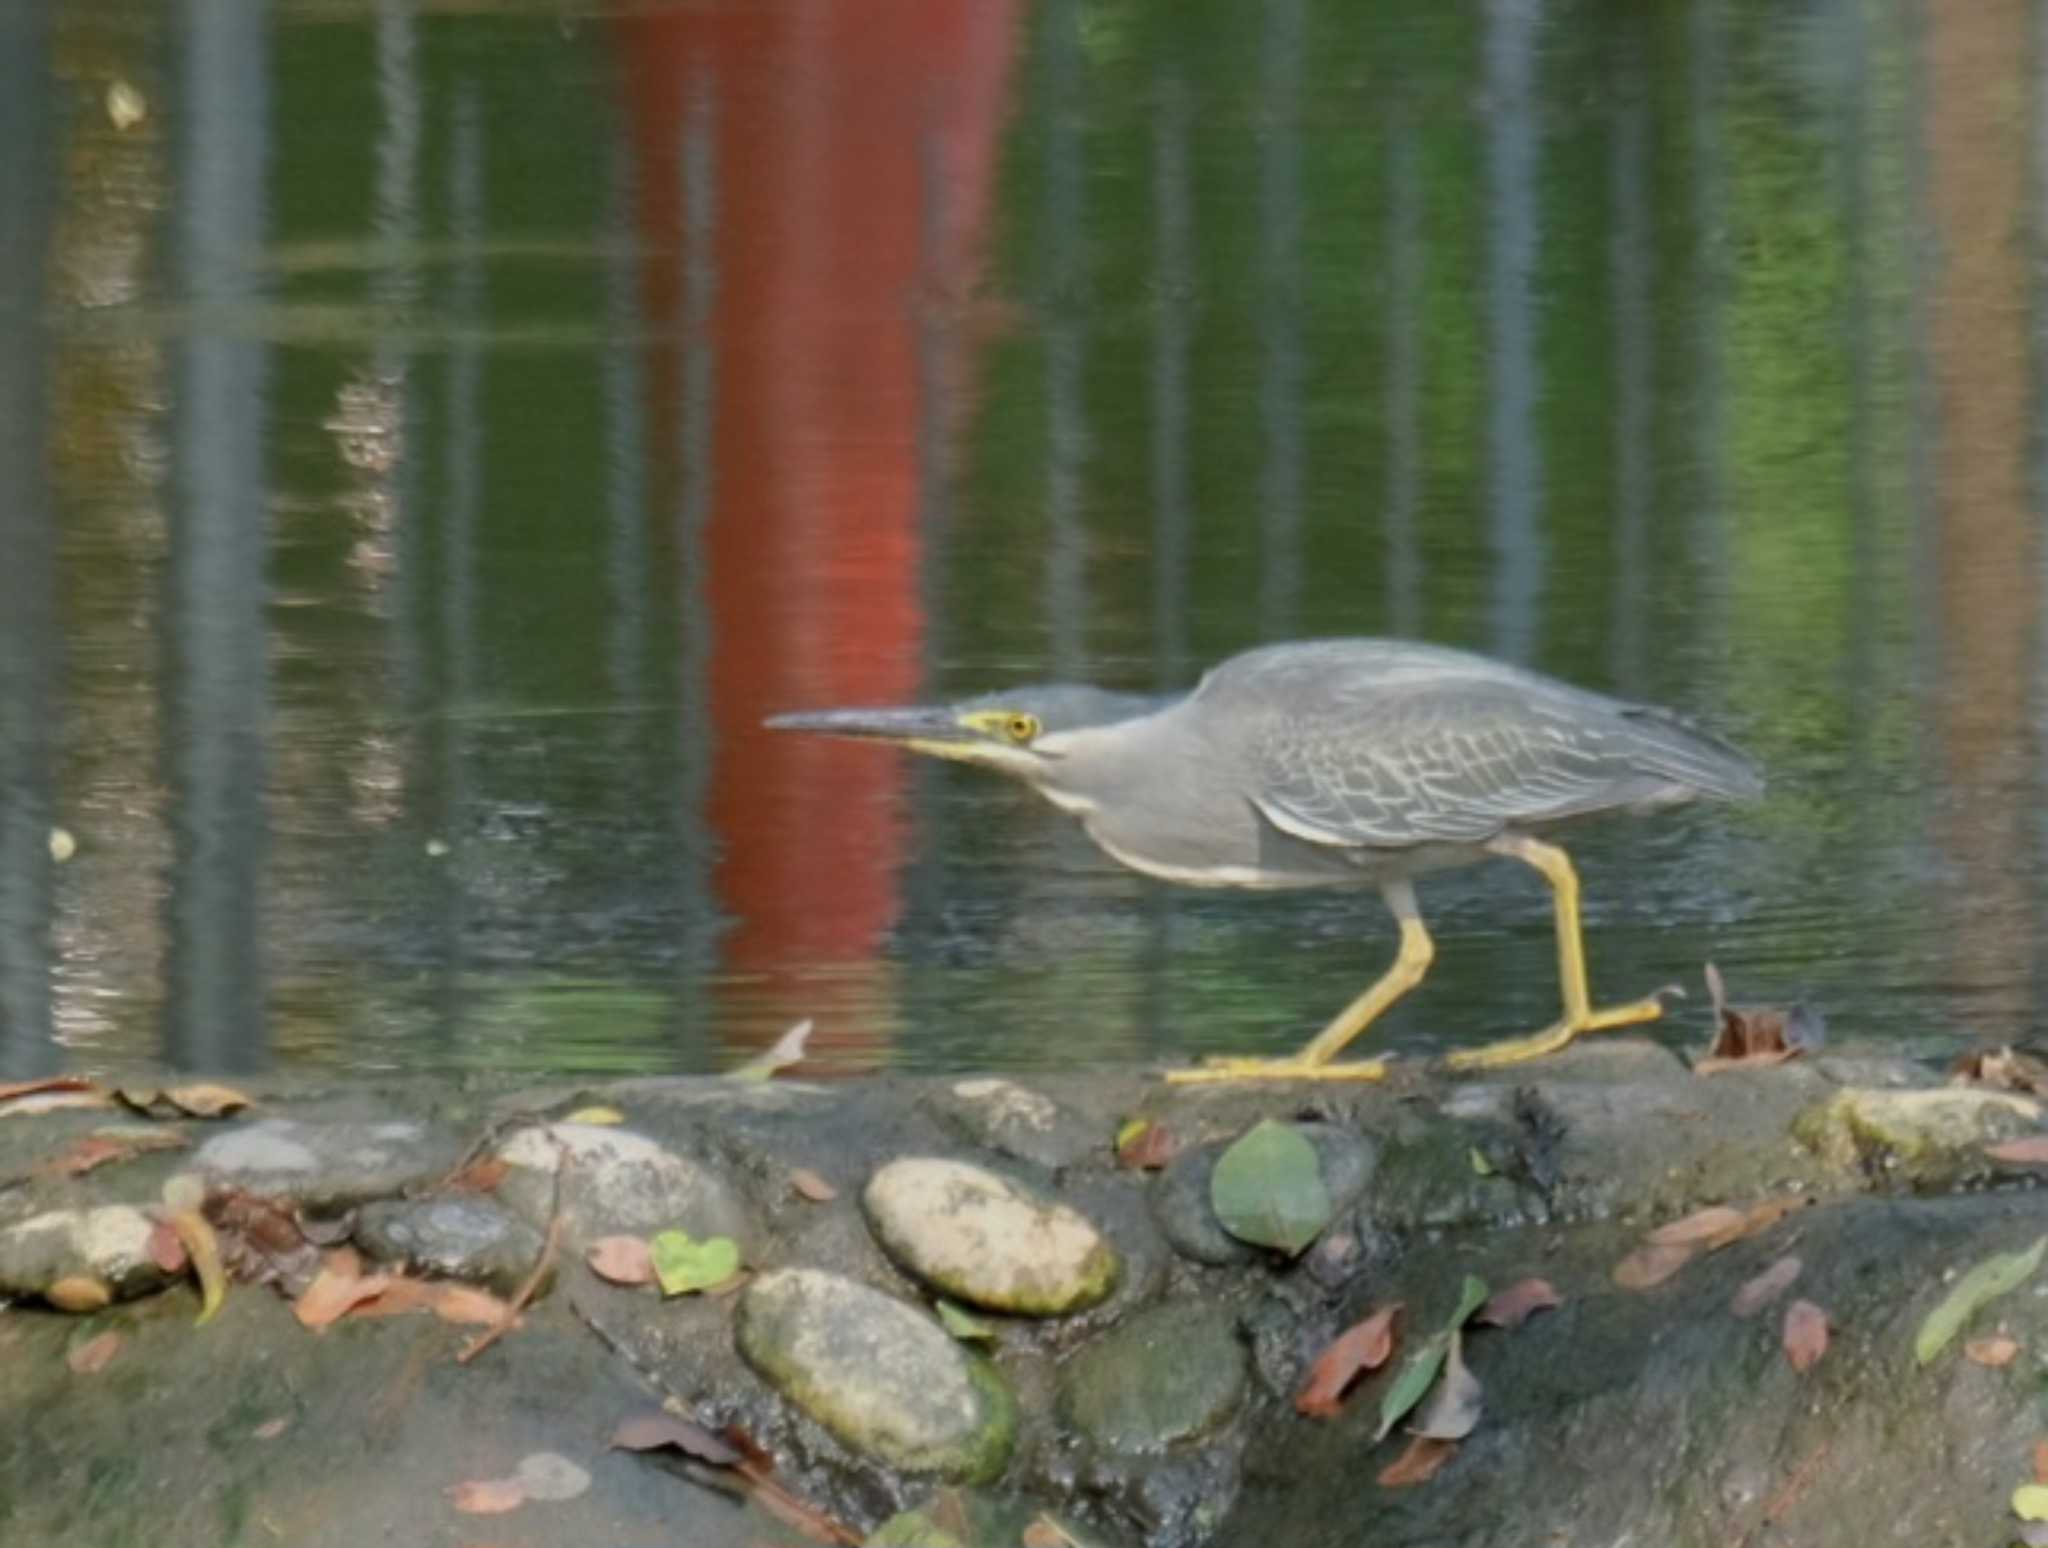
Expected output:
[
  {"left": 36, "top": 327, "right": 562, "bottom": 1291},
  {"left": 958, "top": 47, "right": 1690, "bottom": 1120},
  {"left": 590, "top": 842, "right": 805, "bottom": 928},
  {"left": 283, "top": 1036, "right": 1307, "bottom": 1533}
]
[{"left": 768, "top": 639, "right": 1763, "bottom": 1081}]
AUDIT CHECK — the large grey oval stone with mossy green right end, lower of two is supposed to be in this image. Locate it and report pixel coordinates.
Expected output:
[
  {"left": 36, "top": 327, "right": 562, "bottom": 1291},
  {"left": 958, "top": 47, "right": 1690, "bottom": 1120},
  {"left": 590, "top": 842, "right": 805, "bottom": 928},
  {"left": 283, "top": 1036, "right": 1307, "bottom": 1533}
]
[{"left": 735, "top": 1270, "right": 1018, "bottom": 1482}]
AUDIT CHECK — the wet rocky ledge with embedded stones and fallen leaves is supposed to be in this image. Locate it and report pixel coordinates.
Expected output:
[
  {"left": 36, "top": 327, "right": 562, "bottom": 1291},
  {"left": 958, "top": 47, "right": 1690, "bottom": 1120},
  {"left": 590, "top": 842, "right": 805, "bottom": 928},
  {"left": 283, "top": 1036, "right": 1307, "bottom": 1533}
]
[{"left": 0, "top": 1038, "right": 2048, "bottom": 1548}]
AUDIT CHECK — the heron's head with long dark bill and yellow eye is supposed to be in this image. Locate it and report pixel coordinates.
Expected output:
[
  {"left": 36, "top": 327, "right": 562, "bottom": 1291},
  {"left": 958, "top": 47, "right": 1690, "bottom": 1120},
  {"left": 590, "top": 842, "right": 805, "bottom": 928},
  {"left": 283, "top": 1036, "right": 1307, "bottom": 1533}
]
[{"left": 768, "top": 684, "right": 1161, "bottom": 784}]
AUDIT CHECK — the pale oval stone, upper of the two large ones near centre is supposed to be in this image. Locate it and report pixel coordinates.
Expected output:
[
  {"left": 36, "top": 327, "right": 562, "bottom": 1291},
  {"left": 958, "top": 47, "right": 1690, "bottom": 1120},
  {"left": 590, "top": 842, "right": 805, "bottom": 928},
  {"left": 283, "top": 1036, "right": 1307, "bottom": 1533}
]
[{"left": 860, "top": 1157, "right": 1118, "bottom": 1317}]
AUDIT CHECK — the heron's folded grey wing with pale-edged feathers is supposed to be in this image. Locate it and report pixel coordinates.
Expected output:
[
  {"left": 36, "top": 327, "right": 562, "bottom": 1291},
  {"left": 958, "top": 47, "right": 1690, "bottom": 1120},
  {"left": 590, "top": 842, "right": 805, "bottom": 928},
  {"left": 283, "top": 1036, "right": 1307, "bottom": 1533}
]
[{"left": 1249, "top": 674, "right": 1683, "bottom": 848}]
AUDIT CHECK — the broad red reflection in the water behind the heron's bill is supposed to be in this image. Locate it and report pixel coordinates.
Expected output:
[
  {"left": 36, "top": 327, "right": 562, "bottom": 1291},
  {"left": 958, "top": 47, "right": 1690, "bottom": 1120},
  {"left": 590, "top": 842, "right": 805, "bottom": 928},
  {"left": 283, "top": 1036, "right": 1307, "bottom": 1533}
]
[{"left": 618, "top": 0, "right": 1014, "bottom": 1065}]
